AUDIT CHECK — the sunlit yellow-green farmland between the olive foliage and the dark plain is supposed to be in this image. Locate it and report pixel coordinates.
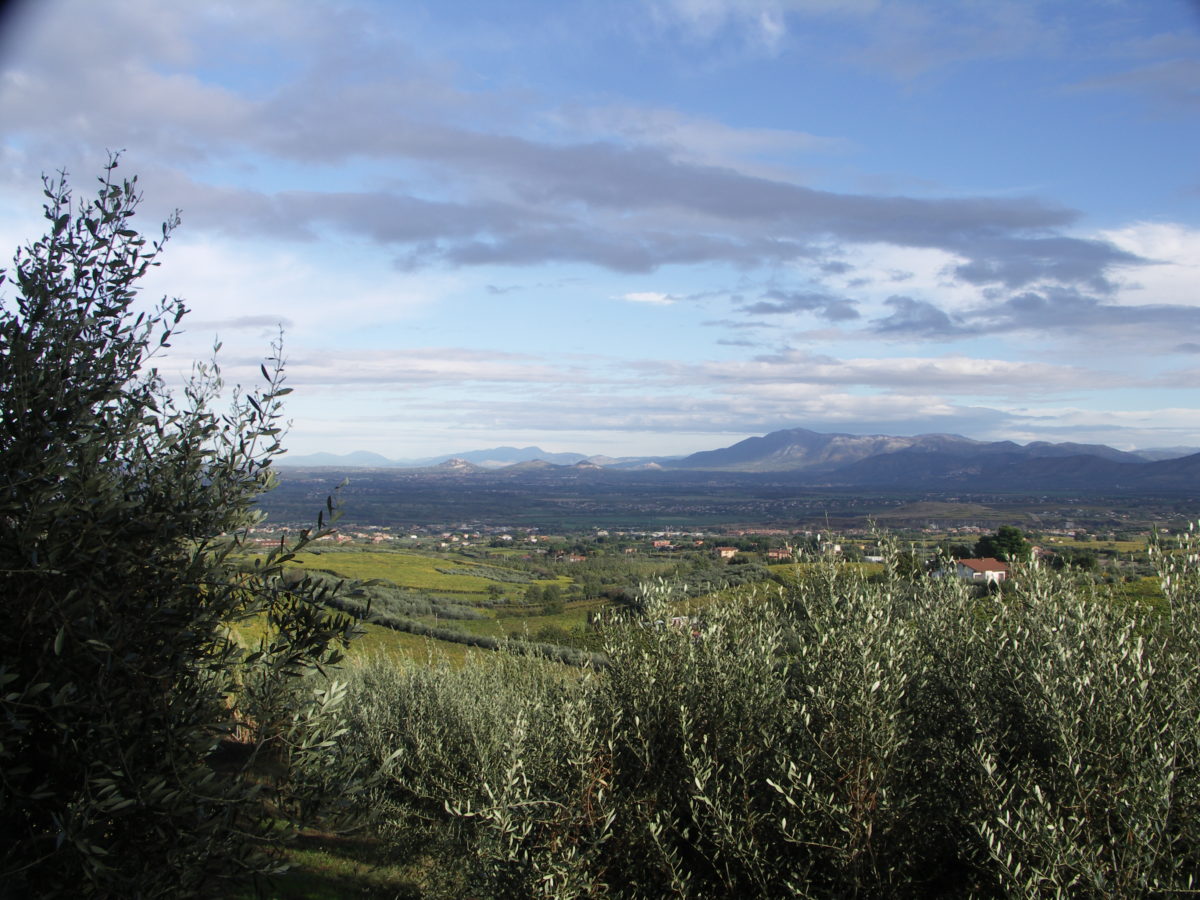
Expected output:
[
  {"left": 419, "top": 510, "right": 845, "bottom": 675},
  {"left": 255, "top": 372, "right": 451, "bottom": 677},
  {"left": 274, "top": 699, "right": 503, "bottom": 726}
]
[{"left": 241, "top": 518, "right": 1159, "bottom": 661}]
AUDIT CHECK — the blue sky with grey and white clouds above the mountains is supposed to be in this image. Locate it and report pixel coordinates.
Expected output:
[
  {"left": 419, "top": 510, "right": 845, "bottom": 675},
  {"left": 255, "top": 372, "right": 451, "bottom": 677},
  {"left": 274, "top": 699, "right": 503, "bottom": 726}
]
[{"left": 0, "top": 0, "right": 1200, "bottom": 460}]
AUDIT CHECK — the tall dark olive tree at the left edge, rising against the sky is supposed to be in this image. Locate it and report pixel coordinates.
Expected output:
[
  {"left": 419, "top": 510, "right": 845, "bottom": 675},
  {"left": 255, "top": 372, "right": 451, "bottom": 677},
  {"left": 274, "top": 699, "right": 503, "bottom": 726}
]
[{"left": 0, "top": 164, "right": 352, "bottom": 898}]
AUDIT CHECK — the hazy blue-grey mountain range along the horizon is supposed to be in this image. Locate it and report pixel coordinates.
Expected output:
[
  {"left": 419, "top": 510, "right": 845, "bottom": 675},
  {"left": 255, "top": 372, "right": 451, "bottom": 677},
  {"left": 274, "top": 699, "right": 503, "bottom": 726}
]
[{"left": 281, "top": 428, "right": 1200, "bottom": 492}]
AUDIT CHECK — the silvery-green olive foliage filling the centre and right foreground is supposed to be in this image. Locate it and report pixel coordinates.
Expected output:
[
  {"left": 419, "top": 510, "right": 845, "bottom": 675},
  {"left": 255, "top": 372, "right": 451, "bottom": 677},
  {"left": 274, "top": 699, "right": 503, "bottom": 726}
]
[{"left": 316, "top": 534, "right": 1200, "bottom": 899}]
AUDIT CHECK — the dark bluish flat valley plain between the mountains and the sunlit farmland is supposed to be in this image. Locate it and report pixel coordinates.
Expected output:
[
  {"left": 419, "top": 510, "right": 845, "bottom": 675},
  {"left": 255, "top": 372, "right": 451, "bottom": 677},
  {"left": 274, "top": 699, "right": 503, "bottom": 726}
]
[{"left": 260, "top": 469, "right": 1200, "bottom": 530}]
